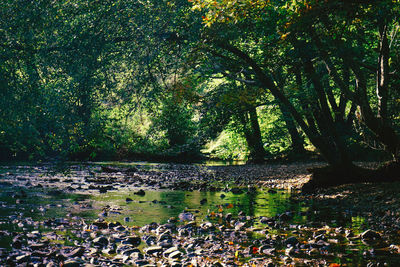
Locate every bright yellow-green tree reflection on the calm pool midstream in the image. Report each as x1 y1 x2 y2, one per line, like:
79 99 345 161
86 191 300 226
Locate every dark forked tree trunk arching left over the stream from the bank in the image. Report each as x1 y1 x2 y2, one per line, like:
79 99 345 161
219 43 400 190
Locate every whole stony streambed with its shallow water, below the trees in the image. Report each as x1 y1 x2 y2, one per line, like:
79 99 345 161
0 162 400 266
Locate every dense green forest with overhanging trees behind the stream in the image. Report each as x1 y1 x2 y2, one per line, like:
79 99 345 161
0 0 400 184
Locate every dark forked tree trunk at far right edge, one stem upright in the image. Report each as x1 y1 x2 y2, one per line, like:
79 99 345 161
311 17 400 161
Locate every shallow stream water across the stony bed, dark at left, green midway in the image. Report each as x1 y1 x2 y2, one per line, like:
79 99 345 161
0 163 400 266
